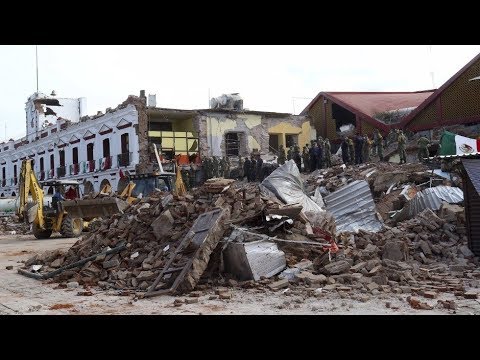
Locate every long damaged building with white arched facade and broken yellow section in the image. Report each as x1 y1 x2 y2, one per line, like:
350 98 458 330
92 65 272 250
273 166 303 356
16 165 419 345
0 90 316 197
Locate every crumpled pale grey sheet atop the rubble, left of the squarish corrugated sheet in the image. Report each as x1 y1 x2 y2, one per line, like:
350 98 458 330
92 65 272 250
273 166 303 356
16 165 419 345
261 160 324 212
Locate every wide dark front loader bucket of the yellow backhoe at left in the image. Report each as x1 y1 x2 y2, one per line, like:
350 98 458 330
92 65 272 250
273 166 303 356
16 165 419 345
59 197 128 219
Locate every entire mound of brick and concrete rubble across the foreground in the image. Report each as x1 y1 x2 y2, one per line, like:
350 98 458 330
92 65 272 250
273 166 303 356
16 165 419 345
16 163 480 309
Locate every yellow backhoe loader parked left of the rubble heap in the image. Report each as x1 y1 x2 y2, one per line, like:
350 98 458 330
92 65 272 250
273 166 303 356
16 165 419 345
16 159 128 239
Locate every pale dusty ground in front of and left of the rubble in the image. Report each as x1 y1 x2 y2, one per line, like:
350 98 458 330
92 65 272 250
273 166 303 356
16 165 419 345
0 235 480 315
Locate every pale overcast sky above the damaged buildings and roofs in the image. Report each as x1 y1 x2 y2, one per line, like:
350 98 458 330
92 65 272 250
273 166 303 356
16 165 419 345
0 45 480 141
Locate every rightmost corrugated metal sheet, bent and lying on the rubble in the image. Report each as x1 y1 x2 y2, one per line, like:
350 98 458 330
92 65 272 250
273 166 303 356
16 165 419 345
394 185 463 221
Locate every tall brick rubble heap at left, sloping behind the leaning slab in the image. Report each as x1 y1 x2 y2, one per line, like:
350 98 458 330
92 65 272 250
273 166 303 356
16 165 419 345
25 179 320 290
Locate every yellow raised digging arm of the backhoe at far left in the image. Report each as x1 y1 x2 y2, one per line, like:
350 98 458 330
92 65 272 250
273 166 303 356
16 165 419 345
17 159 45 229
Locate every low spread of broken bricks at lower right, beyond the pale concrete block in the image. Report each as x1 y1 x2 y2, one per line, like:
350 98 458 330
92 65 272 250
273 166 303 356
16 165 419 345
280 203 480 297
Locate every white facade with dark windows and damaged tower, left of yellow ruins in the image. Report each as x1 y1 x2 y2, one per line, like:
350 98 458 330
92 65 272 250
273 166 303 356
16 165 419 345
0 93 139 197
